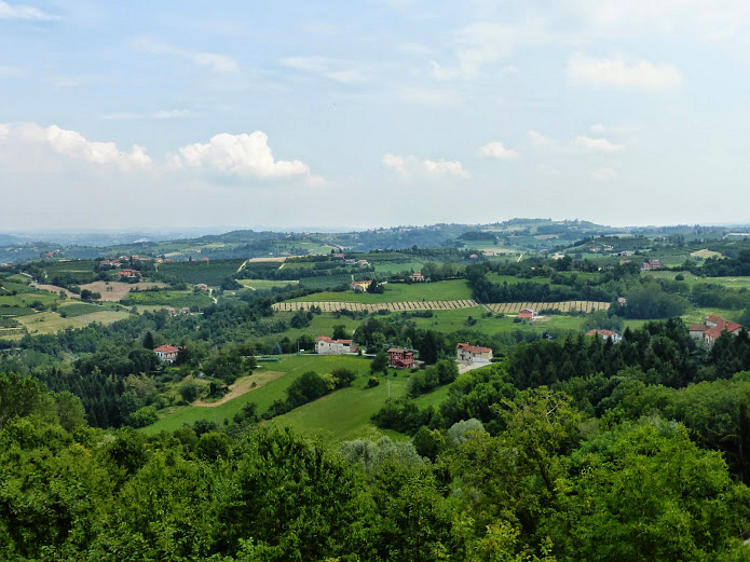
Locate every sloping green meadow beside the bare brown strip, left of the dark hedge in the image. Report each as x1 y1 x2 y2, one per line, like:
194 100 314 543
142 355 388 433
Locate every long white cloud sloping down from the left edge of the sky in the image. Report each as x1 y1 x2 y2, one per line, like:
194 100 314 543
5 123 151 171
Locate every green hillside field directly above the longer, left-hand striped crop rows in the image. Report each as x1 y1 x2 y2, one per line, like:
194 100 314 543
292 279 471 304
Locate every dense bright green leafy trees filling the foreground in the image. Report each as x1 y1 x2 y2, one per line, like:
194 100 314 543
0 366 750 562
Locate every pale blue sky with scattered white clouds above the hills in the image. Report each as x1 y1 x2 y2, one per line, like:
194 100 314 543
0 0 750 231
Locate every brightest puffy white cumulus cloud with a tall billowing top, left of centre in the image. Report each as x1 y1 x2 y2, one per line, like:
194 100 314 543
176 131 312 177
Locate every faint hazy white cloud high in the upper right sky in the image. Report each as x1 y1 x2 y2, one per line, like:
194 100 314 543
567 54 682 90
